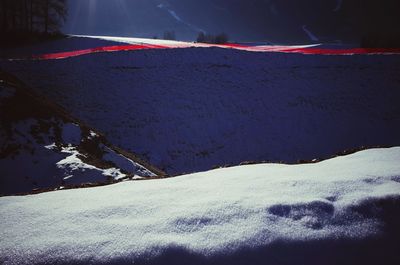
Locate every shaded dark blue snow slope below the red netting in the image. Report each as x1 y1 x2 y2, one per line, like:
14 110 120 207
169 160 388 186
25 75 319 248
0 40 400 174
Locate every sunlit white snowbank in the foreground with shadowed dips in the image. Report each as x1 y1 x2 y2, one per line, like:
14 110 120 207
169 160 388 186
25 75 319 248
0 147 400 265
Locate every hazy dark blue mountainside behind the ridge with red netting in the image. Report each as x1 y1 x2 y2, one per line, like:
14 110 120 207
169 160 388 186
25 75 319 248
64 0 400 43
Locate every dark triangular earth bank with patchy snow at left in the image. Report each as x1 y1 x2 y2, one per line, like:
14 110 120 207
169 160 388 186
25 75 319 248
0 72 161 195
